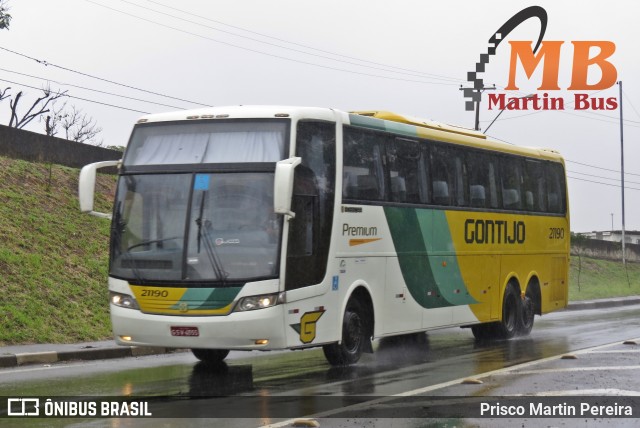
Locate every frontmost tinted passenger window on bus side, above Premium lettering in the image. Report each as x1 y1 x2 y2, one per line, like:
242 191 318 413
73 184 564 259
342 127 386 201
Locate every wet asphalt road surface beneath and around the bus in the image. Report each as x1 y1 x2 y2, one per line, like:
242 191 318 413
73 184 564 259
0 305 640 427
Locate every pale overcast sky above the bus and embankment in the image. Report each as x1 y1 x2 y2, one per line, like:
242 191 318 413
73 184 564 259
0 0 640 232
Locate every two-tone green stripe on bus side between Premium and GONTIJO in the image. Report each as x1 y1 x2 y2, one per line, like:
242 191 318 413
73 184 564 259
384 207 477 308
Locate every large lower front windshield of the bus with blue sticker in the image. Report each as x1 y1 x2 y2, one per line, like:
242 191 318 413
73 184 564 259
110 172 282 285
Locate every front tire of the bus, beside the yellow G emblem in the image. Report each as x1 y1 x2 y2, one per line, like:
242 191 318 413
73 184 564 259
322 299 369 366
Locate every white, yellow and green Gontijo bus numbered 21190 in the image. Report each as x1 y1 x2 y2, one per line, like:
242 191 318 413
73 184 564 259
79 106 570 365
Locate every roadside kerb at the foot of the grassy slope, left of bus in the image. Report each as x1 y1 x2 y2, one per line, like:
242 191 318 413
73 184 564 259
0 345 183 368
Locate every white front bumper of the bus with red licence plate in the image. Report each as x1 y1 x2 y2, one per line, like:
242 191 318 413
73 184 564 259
111 305 286 351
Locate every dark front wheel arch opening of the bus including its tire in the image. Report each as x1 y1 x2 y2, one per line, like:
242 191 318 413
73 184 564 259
322 286 375 366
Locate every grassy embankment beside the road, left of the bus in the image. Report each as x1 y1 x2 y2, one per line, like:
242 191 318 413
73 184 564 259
0 157 115 346
